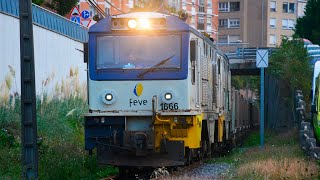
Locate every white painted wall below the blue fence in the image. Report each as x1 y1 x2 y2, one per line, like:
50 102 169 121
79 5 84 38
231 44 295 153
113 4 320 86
0 13 86 94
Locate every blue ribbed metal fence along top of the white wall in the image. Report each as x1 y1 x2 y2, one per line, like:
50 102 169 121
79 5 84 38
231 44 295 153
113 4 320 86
0 0 88 42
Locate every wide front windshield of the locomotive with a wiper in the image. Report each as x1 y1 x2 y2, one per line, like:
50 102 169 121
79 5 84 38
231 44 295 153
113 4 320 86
97 35 181 69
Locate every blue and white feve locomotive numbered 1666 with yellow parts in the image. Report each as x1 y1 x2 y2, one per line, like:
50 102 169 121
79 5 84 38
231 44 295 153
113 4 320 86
85 12 245 167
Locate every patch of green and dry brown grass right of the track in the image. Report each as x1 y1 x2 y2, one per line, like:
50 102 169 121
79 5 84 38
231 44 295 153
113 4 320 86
210 131 320 179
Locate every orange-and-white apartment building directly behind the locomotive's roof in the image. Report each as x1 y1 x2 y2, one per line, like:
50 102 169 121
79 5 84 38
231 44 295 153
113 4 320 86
78 0 218 39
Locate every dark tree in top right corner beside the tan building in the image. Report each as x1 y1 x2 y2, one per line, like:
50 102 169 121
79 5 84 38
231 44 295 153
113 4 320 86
295 0 320 44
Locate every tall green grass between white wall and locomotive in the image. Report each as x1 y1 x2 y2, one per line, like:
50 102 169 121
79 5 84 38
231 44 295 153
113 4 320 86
0 97 118 179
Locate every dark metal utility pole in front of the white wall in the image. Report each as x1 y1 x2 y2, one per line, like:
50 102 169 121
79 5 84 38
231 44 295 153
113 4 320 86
19 0 38 179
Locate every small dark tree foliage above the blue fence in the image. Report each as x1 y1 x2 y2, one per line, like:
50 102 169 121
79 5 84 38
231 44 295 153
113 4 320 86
47 0 79 16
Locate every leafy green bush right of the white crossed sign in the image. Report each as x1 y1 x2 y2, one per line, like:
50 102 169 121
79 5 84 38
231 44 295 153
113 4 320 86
268 37 312 94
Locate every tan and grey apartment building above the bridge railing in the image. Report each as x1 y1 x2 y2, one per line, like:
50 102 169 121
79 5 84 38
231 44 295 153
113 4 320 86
218 0 303 51
